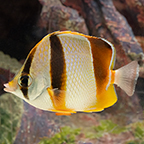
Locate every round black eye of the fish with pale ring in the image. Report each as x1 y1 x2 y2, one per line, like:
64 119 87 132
18 74 32 87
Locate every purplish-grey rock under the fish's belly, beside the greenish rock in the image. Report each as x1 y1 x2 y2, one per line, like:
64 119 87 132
14 102 59 144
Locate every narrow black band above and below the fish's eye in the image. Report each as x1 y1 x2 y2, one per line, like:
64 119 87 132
20 47 36 99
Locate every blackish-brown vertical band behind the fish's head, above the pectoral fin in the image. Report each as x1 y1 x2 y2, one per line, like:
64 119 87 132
50 34 66 90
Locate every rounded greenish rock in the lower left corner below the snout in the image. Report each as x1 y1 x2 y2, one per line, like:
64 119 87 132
0 93 23 144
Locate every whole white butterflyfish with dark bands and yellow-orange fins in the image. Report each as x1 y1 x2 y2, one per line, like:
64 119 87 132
4 31 139 115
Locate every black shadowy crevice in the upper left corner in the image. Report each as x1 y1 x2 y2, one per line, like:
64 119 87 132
0 0 42 60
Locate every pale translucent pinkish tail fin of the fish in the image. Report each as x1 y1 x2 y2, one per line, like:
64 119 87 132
114 61 139 96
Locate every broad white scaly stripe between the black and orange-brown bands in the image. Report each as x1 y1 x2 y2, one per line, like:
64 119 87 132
58 34 96 111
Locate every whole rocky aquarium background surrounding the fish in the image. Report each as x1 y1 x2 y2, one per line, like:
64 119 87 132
0 0 144 144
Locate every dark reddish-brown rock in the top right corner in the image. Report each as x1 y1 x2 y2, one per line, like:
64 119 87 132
113 0 144 36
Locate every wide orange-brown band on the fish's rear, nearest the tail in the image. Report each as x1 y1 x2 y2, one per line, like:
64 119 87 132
88 38 112 93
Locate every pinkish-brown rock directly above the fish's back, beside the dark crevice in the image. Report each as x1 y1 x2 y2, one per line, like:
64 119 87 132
39 0 88 34
